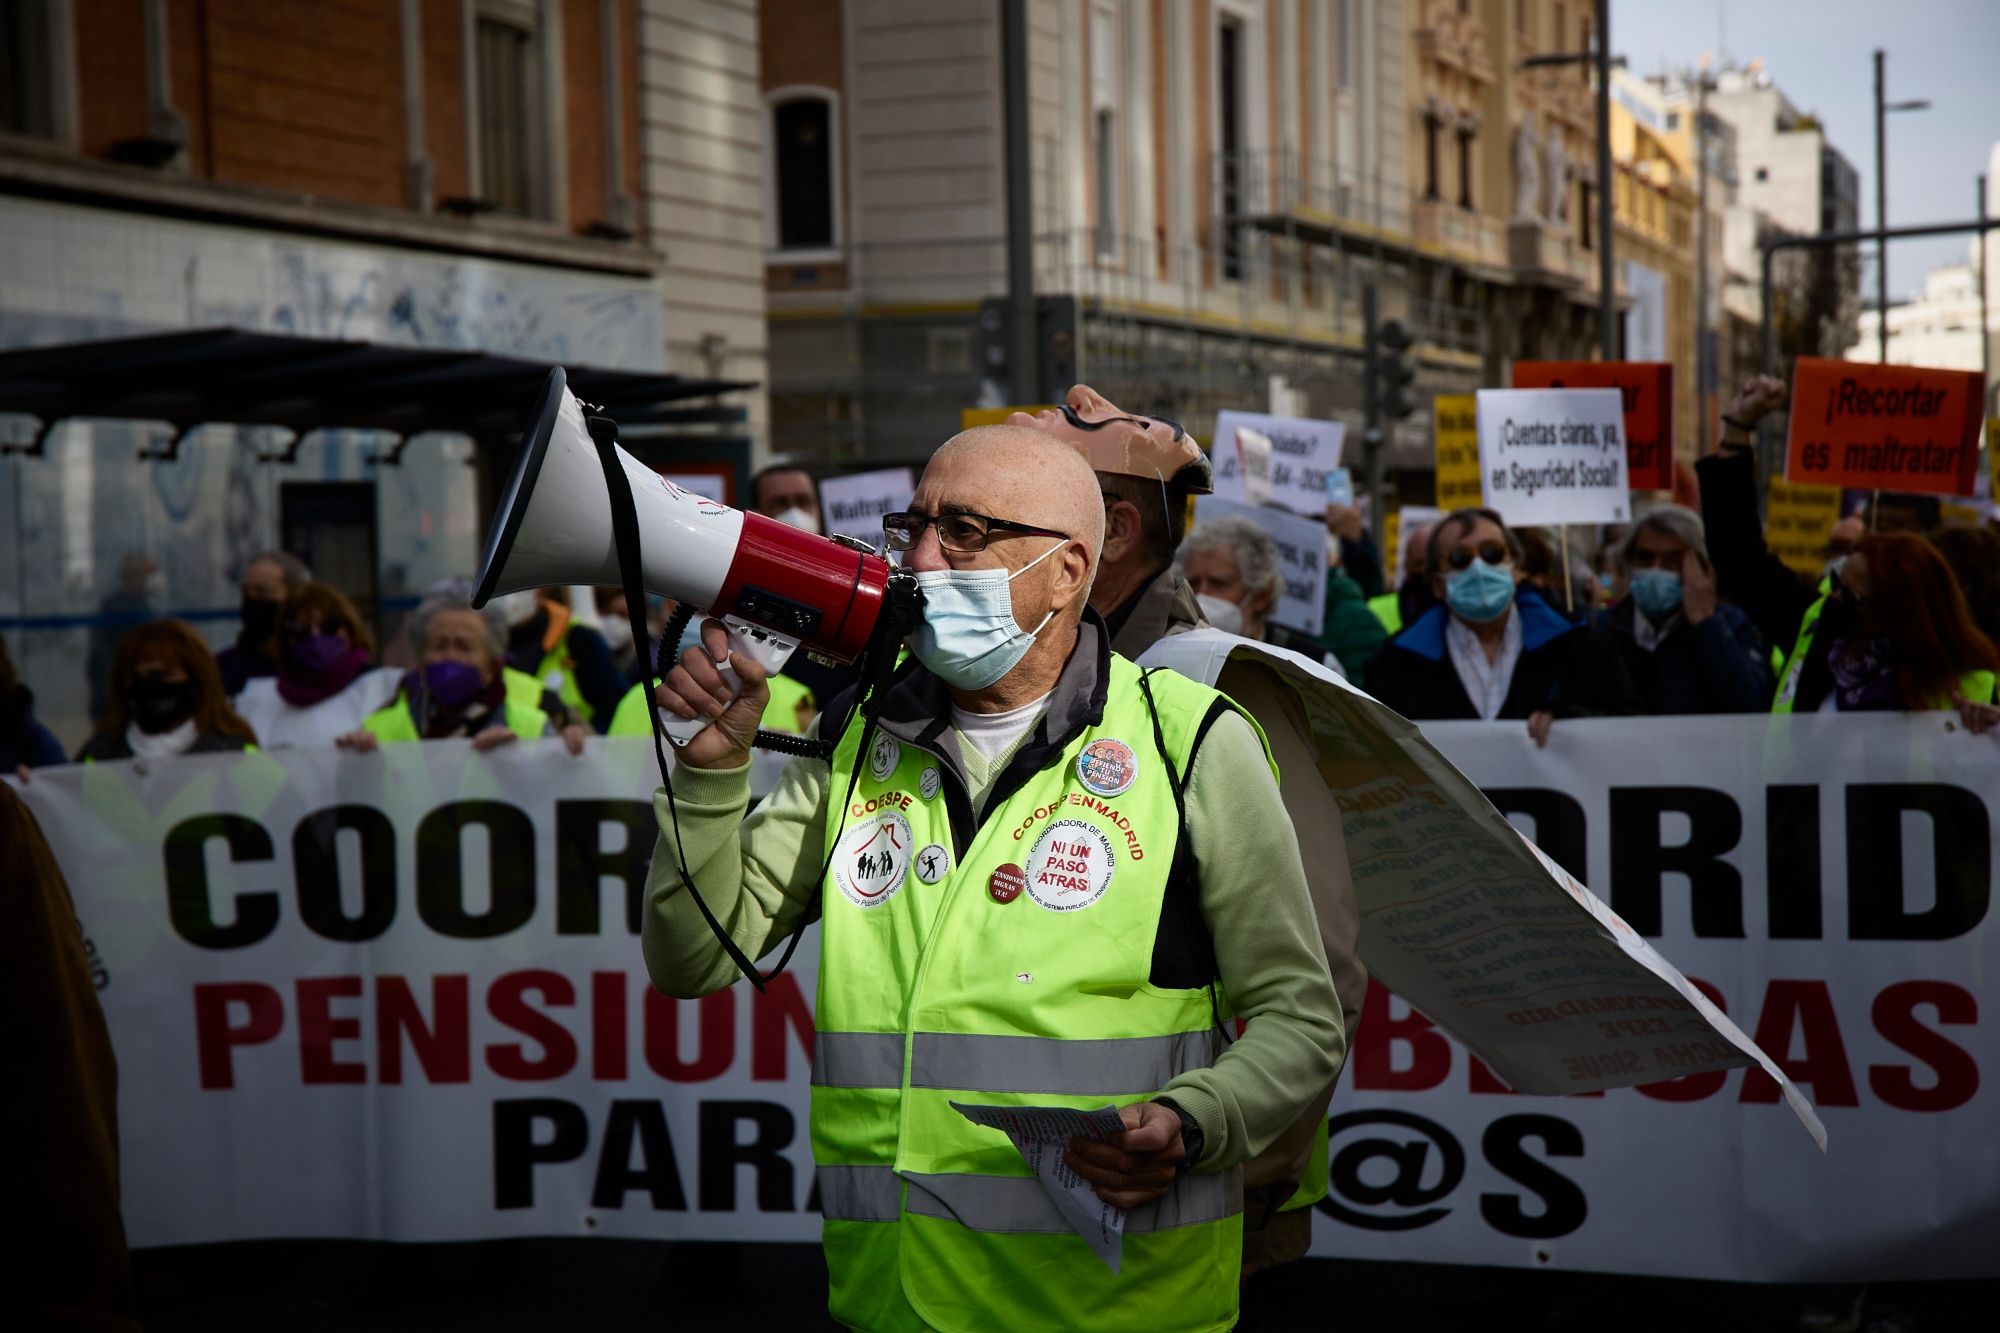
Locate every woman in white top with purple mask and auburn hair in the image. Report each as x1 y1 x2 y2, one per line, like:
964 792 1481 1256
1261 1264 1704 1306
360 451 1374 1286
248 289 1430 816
236 582 402 749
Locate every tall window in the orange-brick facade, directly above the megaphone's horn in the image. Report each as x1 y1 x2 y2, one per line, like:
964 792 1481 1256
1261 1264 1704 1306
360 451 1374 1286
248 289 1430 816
474 0 550 218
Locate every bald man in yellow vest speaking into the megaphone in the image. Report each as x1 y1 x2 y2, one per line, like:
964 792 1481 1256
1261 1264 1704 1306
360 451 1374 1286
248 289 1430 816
642 424 1346 1333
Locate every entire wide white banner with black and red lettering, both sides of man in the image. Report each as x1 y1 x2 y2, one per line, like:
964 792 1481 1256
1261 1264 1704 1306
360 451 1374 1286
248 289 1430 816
20 704 2000 1283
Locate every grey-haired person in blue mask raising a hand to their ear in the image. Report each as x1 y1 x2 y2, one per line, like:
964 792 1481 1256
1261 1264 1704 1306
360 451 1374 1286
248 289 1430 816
1598 504 1772 715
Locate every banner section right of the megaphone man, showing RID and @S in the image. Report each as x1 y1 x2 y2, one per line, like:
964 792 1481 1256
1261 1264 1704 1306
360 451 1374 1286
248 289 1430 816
1288 713 2000 1283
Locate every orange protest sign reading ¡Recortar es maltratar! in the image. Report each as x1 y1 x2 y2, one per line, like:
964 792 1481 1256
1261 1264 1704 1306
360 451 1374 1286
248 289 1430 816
1784 356 1984 494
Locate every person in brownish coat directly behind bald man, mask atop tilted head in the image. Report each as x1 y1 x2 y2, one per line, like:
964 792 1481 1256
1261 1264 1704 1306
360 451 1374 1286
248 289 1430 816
1022 384 1394 1280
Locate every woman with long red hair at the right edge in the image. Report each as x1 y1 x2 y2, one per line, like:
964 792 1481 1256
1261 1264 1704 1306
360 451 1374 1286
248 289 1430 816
1816 532 2000 733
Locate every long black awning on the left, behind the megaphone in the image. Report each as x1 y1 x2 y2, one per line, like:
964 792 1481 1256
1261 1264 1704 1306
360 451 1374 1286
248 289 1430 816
0 328 752 456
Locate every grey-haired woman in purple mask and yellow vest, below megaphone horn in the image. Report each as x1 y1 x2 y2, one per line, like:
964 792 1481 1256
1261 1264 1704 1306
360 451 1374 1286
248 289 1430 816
338 578 584 755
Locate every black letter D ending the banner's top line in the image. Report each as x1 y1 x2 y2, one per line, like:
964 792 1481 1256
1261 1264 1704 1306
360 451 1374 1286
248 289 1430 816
1848 783 1994 939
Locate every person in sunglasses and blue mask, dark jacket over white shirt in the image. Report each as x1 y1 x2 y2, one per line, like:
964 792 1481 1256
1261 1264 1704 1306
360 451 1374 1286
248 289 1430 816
1368 508 1642 747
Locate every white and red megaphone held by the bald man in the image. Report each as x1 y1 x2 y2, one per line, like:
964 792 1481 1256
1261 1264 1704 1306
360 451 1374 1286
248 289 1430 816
472 366 890 743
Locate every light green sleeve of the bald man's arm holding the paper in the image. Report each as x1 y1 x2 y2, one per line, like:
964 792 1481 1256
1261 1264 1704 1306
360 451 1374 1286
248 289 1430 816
1162 713 1346 1171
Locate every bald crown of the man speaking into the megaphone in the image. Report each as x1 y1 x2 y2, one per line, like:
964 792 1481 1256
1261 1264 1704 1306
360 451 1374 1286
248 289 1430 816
918 424 1104 572
